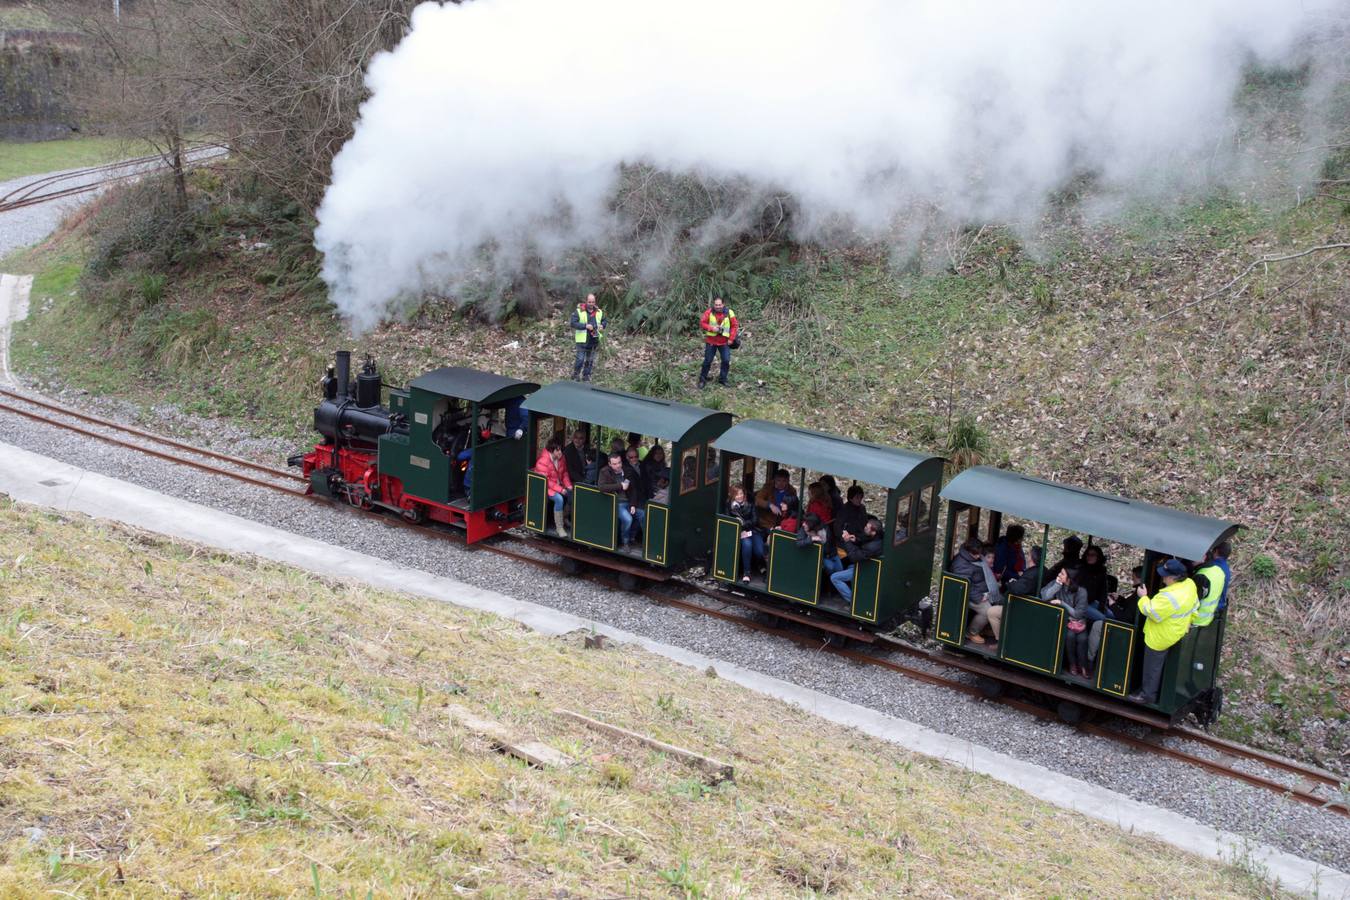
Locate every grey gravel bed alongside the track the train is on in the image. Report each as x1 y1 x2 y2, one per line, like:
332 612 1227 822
0 393 1350 868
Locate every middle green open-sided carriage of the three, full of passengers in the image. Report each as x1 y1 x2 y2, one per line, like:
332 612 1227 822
710 420 942 626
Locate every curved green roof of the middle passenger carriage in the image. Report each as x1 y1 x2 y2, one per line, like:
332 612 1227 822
714 418 941 490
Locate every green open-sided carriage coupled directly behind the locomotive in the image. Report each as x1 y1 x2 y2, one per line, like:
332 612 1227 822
524 382 732 573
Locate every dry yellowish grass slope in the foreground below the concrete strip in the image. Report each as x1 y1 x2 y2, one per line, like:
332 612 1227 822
0 498 1285 897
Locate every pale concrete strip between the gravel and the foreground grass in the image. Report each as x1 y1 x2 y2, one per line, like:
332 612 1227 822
0 444 1350 897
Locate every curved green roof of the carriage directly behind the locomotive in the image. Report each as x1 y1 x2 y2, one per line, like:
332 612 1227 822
524 382 732 443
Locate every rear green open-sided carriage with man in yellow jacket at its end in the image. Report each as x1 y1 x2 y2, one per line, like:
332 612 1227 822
936 466 1239 722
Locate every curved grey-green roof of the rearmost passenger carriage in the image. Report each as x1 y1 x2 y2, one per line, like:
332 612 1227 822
942 466 1241 560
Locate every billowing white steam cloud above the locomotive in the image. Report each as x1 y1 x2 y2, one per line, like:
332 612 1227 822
316 0 1350 329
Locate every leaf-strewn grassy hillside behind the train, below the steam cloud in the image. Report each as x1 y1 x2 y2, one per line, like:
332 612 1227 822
9 165 1350 770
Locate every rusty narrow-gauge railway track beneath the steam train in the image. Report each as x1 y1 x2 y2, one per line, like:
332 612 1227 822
0 387 1350 818
